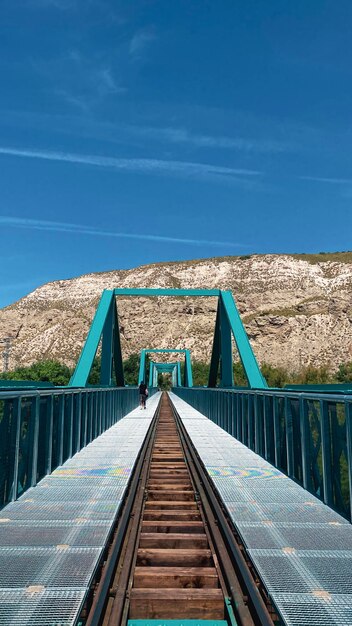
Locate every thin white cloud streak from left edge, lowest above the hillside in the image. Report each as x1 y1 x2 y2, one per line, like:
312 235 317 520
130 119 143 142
0 215 248 248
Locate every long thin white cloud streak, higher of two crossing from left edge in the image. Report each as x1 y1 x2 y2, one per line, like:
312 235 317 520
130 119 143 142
0 147 262 182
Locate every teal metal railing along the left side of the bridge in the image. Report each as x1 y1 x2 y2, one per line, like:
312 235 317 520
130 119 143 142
0 387 145 508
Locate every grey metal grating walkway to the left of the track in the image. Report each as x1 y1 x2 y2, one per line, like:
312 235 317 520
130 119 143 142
0 394 160 626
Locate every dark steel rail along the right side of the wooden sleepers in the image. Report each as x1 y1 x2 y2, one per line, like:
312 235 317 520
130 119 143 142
169 399 273 626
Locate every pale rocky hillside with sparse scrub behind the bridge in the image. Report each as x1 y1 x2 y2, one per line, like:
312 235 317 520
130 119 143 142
0 253 352 370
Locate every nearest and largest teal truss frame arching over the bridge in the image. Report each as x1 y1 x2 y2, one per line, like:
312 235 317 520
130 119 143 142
68 289 267 389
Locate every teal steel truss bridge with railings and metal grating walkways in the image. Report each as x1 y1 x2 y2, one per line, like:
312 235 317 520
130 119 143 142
0 289 352 626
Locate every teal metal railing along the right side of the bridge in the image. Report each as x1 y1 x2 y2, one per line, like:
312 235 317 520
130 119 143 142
173 387 352 520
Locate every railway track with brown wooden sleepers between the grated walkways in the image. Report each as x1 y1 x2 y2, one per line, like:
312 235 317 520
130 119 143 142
82 393 274 626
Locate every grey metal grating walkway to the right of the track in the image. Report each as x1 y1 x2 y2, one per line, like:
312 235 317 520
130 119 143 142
170 393 352 626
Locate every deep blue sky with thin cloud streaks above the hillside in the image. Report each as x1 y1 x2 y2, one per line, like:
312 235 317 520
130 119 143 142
0 0 352 306
